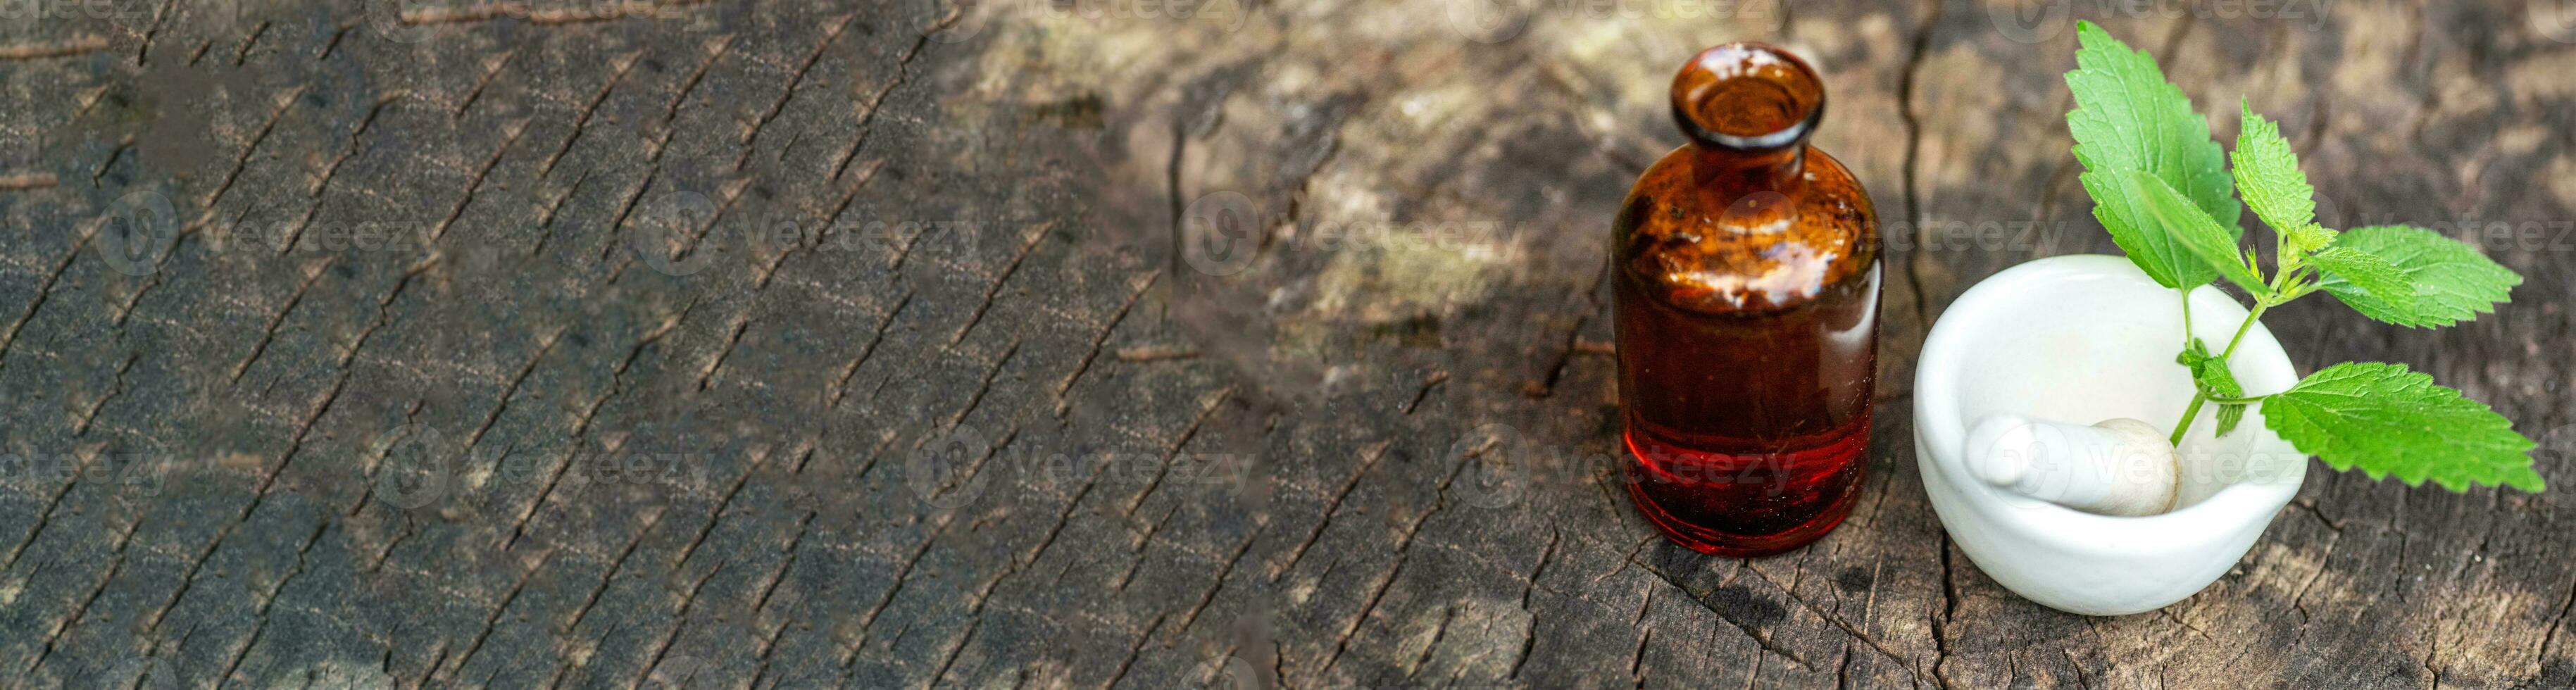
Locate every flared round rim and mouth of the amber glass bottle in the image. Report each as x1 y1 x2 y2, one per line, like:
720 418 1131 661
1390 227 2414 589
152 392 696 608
1672 44 1824 152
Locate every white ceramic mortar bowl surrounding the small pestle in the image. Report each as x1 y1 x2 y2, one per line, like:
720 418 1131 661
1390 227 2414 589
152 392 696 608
1914 255 2308 615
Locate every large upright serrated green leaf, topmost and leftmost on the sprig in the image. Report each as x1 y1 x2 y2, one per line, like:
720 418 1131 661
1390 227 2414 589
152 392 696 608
2066 20 2244 289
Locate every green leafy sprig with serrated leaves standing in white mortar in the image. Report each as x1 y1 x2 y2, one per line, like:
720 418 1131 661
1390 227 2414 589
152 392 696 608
2066 20 2545 491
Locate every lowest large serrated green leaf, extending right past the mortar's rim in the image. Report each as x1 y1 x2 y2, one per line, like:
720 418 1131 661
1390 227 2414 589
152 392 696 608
2262 363 2545 491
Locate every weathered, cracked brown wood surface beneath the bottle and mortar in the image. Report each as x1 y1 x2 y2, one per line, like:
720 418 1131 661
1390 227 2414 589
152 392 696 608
0 0 2576 687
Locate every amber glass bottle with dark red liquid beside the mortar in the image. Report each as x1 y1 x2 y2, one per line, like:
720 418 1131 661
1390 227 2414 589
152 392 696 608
1610 44 1878 556
